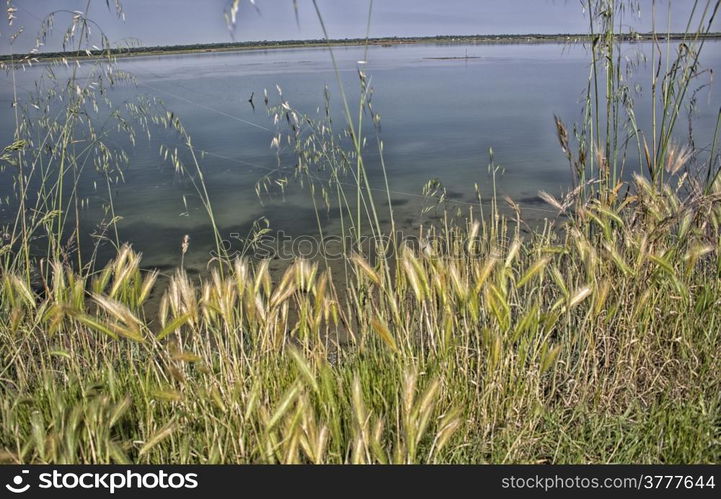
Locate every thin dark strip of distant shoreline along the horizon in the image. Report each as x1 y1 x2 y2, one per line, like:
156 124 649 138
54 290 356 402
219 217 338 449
0 33 721 62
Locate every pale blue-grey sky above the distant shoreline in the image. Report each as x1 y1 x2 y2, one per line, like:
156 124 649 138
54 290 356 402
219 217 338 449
0 0 721 54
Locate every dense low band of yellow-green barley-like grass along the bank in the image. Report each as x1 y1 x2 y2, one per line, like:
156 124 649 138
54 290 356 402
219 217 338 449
0 178 721 463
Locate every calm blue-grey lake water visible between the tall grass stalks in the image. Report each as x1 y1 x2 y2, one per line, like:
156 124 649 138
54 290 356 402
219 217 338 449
0 43 721 267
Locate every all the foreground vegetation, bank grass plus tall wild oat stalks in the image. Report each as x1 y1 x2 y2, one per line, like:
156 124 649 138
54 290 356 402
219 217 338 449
0 0 721 463
